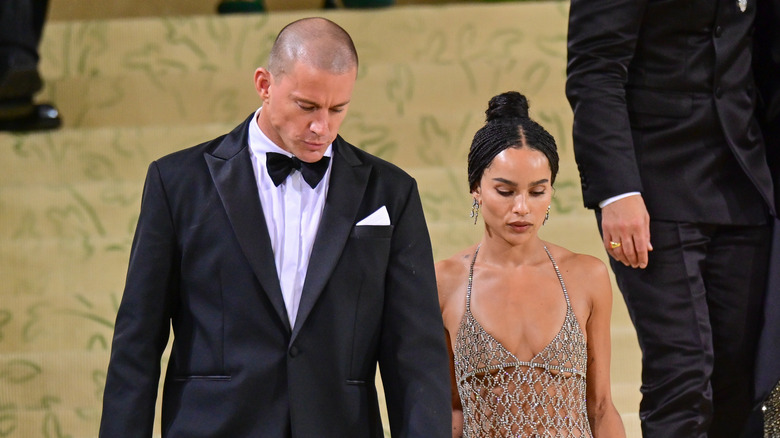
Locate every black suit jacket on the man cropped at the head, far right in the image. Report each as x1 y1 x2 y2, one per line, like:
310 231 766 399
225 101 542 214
566 0 774 225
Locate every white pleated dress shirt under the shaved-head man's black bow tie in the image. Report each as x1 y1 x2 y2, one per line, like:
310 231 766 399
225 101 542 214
249 108 333 327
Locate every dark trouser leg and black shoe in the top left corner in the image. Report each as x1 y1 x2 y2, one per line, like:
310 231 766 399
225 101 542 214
0 0 61 132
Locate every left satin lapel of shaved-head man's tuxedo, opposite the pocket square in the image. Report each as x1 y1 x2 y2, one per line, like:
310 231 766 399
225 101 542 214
205 116 290 331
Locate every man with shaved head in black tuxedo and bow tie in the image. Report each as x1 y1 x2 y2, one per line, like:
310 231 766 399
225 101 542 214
100 18 451 438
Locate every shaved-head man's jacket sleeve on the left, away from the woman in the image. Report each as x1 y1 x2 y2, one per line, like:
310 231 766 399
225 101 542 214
99 163 177 438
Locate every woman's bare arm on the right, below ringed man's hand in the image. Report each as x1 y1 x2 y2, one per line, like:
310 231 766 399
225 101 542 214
580 257 626 438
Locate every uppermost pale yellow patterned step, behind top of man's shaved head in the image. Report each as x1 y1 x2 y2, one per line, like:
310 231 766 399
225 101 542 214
41 2 568 76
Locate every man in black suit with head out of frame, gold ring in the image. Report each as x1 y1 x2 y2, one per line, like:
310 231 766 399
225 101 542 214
566 0 775 438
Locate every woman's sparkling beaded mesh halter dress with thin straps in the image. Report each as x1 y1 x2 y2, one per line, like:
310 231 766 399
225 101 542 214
453 247 592 438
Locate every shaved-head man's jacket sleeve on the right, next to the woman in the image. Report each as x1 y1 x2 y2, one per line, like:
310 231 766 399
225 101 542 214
379 179 452 438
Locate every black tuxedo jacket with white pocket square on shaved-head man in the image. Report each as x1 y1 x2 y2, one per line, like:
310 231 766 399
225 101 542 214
100 117 451 438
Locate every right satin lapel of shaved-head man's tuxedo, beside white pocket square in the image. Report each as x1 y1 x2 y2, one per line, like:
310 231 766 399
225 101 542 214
290 137 371 342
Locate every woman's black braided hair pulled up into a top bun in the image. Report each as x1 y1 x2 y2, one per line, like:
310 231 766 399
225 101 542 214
468 91 558 192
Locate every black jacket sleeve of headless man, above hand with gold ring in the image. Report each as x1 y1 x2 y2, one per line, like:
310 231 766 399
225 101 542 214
566 0 647 208
